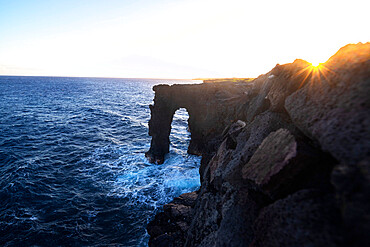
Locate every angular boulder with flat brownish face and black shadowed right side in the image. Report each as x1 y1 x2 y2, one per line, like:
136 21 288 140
242 129 336 200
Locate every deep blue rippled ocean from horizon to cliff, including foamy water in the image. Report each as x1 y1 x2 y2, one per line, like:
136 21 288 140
0 76 200 246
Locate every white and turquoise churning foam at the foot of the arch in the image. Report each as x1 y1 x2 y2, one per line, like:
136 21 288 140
109 152 200 208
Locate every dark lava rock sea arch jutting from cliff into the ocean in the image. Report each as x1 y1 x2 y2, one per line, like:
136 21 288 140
145 83 249 164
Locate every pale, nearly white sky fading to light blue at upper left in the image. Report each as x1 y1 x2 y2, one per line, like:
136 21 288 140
0 0 370 79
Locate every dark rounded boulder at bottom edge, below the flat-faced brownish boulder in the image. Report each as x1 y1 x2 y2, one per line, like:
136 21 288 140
250 190 342 247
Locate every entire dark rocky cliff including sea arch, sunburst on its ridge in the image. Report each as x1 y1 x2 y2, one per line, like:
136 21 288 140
146 43 370 247
